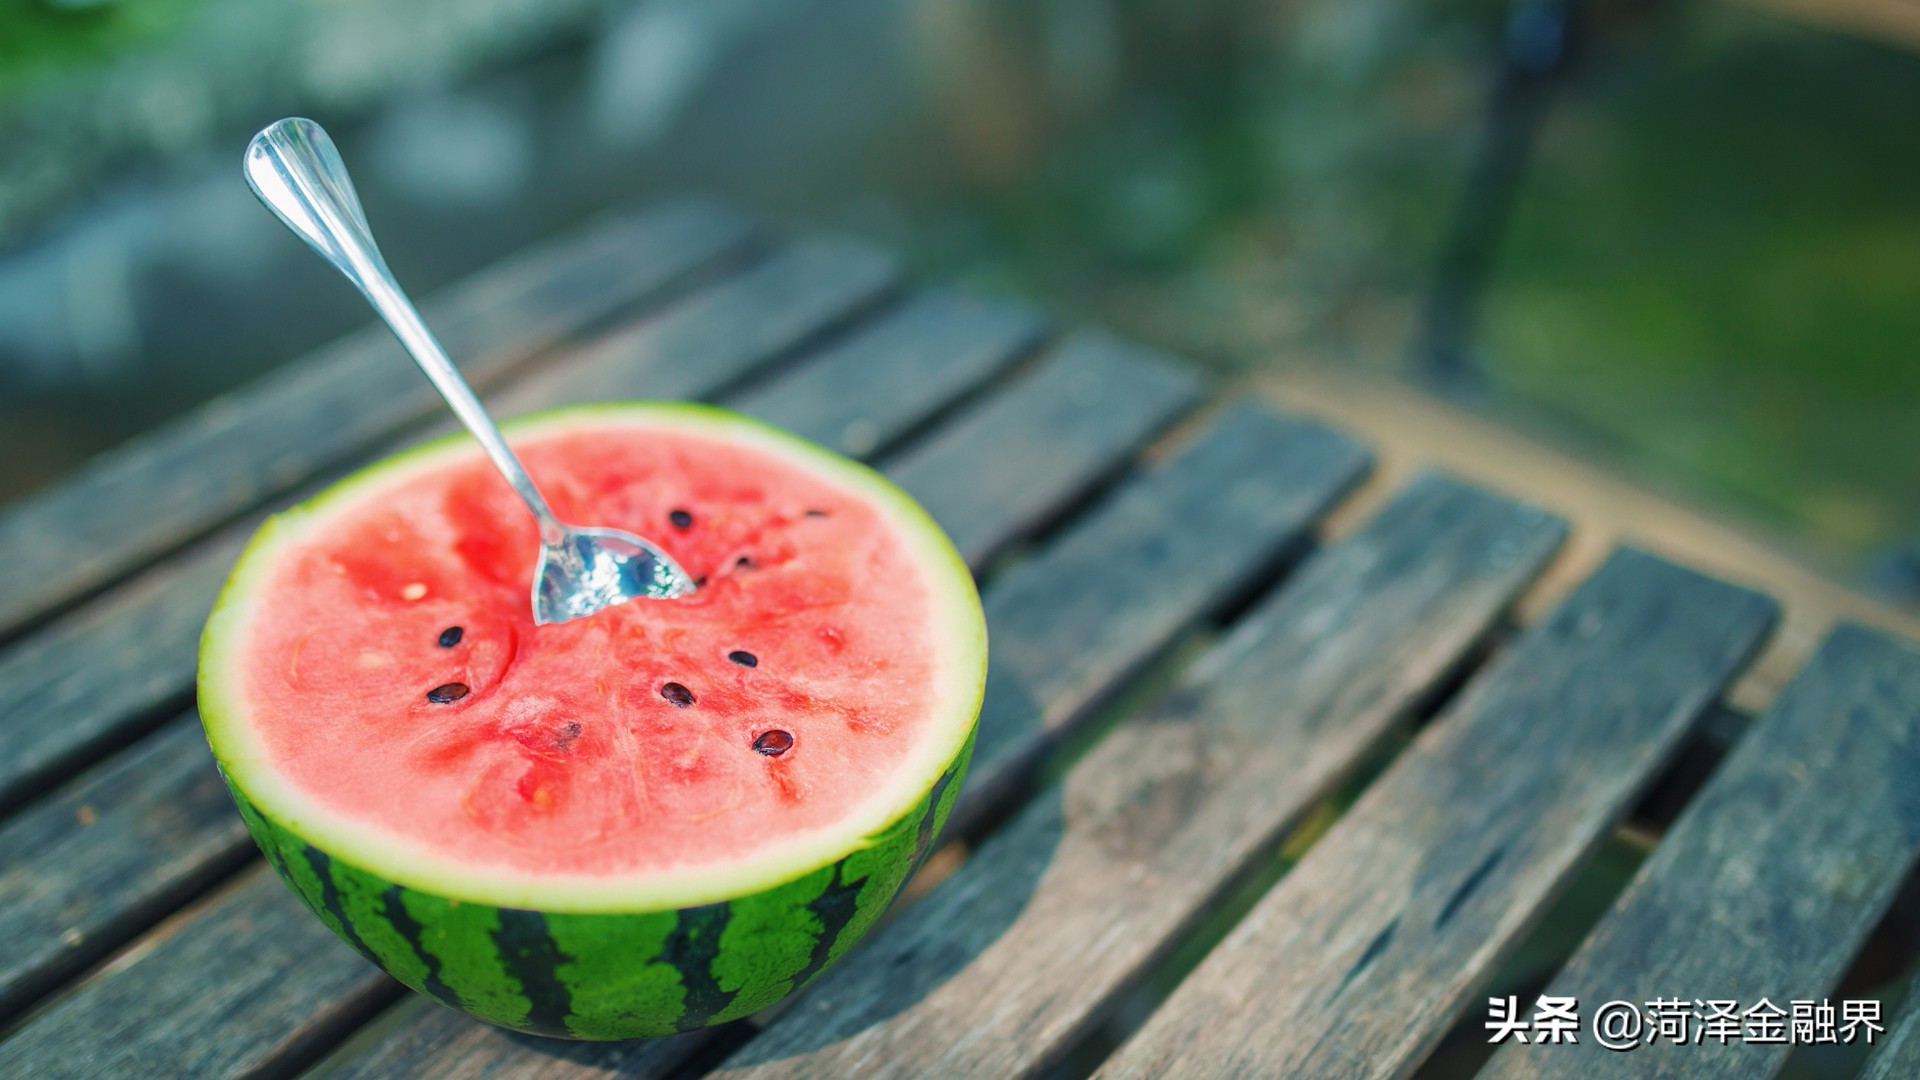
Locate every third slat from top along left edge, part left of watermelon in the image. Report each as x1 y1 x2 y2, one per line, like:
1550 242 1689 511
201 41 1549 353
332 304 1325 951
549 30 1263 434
0 717 253 1024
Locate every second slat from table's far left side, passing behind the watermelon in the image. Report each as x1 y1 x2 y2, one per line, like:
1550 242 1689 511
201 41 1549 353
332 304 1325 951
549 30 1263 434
0 238 898 813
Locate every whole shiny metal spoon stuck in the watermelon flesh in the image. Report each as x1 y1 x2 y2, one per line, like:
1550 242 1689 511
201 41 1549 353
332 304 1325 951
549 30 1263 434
246 117 693 623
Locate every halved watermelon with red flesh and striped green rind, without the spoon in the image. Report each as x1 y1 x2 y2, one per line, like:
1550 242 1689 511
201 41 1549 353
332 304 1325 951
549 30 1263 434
200 404 987 1038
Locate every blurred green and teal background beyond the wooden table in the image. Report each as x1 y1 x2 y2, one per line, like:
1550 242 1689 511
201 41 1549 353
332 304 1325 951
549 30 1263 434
0 0 1920 1076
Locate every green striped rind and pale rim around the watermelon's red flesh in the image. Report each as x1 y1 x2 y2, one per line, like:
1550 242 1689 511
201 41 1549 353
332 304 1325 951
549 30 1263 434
198 402 987 1038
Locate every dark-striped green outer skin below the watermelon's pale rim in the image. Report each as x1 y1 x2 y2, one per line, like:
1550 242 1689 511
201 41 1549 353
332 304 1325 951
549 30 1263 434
227 734 973 1040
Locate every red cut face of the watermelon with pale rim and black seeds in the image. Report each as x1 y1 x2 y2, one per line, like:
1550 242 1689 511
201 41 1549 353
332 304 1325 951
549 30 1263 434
204 407 983 911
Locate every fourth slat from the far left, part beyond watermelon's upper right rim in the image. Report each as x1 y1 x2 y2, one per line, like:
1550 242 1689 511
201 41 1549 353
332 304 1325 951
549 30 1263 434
895 332 1200 563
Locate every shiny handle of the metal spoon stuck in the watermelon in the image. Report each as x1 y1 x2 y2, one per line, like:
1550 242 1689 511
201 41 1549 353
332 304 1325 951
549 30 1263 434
246 117 564 544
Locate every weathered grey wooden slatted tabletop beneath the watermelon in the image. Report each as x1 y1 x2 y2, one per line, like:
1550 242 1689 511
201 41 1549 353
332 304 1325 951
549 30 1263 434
0 202 1920 1078
